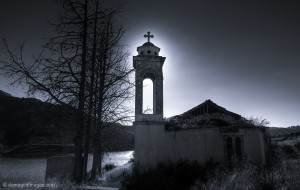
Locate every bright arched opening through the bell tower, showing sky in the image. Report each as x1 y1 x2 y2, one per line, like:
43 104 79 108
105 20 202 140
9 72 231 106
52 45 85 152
143 78 153 114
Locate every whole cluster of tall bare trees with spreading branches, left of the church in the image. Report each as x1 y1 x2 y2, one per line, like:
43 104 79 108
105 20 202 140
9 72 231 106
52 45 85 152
0 0 133 183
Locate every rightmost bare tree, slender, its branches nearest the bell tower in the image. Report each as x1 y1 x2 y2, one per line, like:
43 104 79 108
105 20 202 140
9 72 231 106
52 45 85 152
86 15 133 180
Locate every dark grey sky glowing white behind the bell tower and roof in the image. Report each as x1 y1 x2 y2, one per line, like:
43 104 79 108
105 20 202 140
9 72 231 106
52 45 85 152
0 0 300 127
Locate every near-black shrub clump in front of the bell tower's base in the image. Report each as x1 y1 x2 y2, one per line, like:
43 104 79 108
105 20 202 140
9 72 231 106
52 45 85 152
122 160 206 190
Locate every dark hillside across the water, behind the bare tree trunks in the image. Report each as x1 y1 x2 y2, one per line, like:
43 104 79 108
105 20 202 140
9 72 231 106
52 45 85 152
0 91 134 154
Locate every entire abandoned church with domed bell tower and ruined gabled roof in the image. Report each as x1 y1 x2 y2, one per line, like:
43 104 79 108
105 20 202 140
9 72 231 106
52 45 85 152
133 32 269 167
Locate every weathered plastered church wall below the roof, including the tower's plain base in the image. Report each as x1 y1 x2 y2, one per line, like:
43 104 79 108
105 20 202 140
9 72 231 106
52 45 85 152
135 122 266 166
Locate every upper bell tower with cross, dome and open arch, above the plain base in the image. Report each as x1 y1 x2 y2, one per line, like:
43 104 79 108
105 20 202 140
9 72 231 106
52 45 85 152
133 32 166 121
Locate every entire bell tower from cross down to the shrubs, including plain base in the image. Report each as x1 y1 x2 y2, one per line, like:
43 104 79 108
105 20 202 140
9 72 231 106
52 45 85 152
133 32 166 166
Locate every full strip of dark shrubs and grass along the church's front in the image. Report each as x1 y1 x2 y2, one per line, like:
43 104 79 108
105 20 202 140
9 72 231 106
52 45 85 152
122 157 300 190
